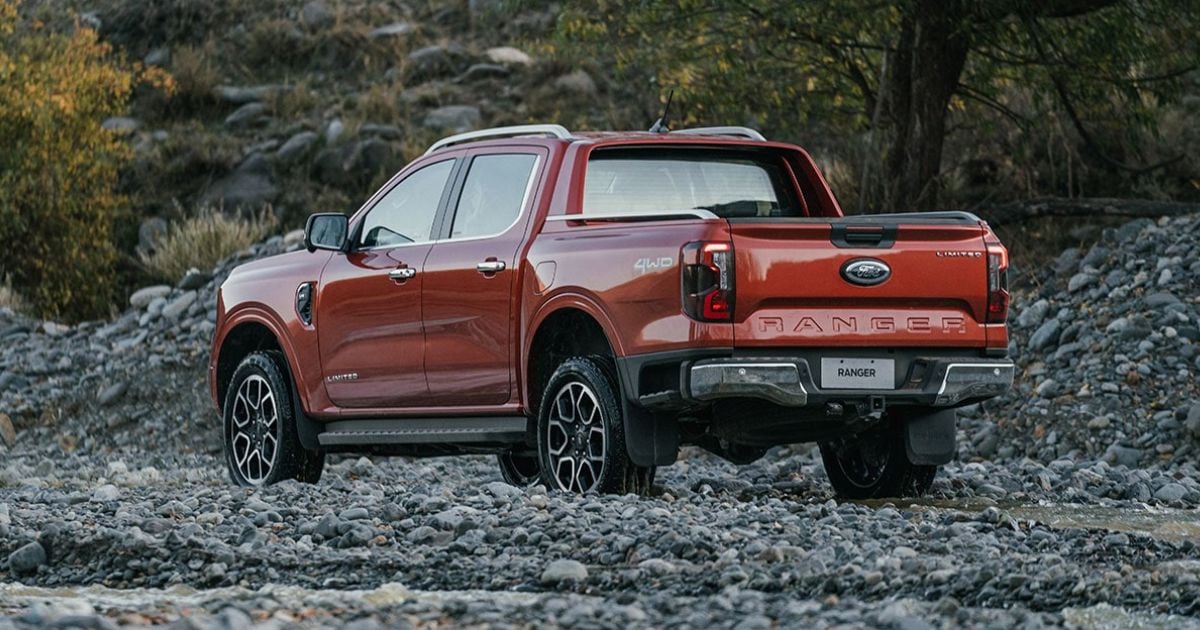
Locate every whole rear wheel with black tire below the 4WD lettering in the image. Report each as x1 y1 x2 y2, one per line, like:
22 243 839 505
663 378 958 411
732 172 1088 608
538 356 654 494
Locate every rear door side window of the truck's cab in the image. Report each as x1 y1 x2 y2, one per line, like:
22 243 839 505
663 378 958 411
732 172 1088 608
450 154 538 239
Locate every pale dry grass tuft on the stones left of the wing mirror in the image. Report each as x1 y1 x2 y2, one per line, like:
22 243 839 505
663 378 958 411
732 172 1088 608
140 209 275 282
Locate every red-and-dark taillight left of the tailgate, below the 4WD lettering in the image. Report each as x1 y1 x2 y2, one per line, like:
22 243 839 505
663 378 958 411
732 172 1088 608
680 241 733 322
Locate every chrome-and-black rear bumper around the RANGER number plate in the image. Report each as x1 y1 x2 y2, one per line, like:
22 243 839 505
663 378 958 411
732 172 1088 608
680 358 1015 409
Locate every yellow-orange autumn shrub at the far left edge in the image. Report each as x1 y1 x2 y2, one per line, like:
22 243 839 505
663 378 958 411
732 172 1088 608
0 0 169 320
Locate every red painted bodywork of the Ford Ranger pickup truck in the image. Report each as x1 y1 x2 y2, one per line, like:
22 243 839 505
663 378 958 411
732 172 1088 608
210 133 1008 420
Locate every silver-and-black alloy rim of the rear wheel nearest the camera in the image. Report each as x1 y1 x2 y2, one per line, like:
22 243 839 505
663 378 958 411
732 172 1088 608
546 380 608 493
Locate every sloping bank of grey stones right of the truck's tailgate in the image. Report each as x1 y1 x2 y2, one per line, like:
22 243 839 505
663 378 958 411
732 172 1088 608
960 216 1200 465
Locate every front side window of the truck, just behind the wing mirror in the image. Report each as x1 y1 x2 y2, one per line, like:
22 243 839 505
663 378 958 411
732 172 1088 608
359 160 454 248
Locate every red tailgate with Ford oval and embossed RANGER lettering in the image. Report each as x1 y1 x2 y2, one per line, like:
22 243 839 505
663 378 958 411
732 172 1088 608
730 215 988 348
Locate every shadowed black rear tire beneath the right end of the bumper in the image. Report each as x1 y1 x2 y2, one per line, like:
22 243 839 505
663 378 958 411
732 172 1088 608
821 418 938 499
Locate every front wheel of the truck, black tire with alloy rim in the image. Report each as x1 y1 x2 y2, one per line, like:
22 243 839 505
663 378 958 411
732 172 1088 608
222 352 325 486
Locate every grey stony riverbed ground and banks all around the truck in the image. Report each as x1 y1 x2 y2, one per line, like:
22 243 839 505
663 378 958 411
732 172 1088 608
0 218 1200 628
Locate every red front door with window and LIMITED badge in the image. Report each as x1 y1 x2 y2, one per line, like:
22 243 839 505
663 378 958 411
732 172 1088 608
313 158 455 408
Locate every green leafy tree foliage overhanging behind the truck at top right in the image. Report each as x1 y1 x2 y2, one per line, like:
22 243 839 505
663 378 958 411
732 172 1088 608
542 0 1200 208
